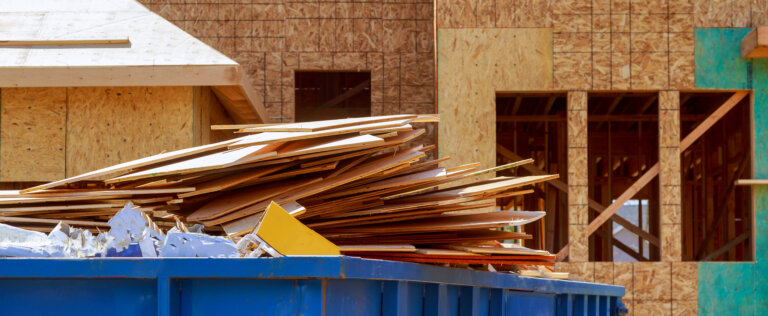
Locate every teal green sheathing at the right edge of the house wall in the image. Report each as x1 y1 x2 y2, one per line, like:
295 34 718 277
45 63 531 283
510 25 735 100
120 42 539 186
695 28 768 315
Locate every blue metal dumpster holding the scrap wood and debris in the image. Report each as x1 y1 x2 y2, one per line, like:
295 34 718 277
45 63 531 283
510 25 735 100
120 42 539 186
0 257 624 316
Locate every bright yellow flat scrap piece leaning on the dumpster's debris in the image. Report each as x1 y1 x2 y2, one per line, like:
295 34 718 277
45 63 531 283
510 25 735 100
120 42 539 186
256 202 341 256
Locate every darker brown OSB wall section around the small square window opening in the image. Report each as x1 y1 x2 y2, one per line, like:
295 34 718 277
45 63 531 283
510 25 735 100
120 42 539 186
141 0 435 128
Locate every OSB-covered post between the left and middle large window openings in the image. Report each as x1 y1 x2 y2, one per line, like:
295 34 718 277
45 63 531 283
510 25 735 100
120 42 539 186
567 91 589 262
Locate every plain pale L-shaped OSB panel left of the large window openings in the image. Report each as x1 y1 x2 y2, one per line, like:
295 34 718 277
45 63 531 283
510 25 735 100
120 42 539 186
437 29 552 181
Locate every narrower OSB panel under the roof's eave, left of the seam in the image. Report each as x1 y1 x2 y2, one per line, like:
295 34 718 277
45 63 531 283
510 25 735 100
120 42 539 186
0 88 67 182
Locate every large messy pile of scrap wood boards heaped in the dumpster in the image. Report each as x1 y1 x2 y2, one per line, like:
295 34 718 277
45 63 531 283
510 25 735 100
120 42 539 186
0 115 557 265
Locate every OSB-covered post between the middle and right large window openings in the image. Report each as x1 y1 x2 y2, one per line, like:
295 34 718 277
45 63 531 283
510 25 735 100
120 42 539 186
659 91 682 261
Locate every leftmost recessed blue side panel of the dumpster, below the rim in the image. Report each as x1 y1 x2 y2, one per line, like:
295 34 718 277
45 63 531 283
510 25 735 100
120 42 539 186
0 278 157 316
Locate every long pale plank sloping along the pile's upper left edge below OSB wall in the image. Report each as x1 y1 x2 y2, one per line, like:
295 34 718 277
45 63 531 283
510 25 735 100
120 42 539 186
21 139 237 193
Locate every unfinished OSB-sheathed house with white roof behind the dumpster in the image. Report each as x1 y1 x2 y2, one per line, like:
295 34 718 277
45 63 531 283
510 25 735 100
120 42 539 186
0 0 768 315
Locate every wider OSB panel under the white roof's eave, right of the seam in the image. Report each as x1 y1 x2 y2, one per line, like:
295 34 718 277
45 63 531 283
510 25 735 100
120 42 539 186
66 87 195 177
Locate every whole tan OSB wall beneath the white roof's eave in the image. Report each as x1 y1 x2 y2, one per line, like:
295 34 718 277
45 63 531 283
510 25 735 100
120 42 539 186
0 87 200 182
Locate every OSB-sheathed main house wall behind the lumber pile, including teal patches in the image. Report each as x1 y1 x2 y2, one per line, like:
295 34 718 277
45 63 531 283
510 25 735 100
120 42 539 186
132 0 768 315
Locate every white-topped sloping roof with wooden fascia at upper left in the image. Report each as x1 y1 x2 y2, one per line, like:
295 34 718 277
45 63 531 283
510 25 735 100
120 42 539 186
0 0 267 123
